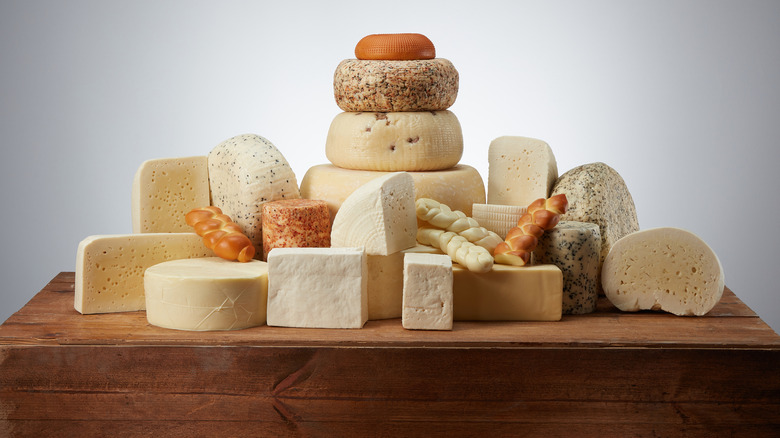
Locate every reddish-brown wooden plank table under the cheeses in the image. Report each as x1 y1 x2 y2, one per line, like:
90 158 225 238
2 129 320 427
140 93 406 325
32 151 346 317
0 272 780 437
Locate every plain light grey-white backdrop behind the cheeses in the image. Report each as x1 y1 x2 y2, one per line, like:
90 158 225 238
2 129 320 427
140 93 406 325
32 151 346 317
0 0 780 331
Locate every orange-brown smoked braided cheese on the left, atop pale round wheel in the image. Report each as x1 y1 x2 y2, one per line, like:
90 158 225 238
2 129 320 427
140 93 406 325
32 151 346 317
184 206 255 263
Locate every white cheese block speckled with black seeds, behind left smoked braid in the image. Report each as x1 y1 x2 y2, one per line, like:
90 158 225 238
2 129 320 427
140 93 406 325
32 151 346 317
208 134 300 258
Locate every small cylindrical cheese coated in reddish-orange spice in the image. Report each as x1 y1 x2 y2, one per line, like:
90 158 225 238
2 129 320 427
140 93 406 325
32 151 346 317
263 199 330 260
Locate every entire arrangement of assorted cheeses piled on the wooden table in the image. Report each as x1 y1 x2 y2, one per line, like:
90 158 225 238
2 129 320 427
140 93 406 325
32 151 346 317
74 30 724 336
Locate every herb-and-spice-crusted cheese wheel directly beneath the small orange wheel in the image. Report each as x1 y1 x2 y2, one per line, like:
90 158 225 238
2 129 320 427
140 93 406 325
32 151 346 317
333 58 458 112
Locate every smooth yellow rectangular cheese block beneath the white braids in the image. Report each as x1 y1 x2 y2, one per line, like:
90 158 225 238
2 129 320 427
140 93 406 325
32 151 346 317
452 264 563 321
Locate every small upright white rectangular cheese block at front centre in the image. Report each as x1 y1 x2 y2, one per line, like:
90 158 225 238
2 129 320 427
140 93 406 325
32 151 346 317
401 253 452 330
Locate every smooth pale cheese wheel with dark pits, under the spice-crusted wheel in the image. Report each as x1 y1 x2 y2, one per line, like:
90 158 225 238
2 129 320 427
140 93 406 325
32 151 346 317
325 111 463 172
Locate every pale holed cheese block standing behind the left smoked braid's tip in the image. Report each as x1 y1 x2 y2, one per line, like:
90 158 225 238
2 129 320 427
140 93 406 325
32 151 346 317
131 157 211 233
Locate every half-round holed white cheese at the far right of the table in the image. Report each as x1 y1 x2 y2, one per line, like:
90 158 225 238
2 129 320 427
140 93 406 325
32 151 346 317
601 227 725 315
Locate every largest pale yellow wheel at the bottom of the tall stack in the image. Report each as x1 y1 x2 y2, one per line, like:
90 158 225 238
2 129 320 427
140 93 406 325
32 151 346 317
301 164 485 220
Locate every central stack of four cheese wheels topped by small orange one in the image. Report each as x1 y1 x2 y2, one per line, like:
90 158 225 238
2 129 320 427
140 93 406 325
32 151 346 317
301 34 486 220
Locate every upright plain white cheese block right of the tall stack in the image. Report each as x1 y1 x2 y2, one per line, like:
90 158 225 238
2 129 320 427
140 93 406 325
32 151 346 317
487 136 558 207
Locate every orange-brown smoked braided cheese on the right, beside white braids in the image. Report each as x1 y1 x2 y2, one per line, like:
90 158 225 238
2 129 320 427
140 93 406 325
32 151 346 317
493 193 569 266
